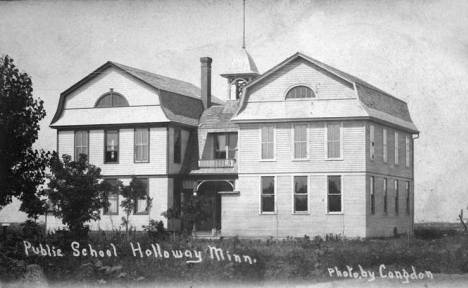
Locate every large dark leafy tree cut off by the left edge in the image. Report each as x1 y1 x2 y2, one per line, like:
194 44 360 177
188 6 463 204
0 56 51 219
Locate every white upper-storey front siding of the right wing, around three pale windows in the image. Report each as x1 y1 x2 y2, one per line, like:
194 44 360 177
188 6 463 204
239 121 365 174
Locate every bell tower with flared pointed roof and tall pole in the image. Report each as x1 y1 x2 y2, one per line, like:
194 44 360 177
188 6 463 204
221 0 260 100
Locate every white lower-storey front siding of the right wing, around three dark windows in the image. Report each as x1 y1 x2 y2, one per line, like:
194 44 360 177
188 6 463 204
221 173 366 237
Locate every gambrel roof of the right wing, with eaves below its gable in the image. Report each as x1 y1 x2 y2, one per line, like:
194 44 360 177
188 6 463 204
233 52 419 133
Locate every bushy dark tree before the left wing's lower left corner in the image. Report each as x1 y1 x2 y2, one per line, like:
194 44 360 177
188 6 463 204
45 153 114 234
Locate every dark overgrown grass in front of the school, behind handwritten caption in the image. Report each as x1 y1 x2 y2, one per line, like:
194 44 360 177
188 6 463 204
0 222 468 284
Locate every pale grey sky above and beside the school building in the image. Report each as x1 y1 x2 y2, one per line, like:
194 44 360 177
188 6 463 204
0 0 468 222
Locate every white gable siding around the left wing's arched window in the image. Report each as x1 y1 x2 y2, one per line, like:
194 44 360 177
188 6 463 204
65 67 159 109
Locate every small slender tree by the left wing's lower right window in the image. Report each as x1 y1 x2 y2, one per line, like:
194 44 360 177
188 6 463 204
120 176 152 232
